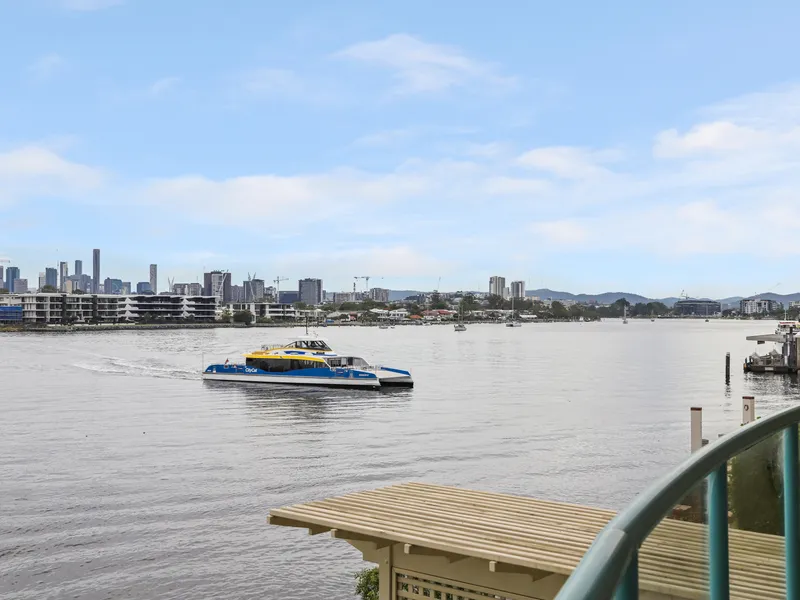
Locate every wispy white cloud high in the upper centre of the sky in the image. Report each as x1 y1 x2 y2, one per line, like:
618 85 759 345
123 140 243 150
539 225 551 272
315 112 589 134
336 33 514 94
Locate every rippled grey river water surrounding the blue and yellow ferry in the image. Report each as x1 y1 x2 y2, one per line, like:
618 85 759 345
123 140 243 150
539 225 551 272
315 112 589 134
0 320 800 600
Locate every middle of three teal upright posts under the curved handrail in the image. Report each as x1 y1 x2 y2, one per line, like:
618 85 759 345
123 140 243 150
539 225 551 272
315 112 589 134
708 461 730 600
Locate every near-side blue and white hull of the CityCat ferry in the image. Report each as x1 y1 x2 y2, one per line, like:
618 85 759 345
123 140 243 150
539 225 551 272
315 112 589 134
203 365 380 389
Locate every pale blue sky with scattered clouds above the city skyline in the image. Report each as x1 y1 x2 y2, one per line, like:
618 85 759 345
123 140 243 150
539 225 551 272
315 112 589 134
0 0 800 297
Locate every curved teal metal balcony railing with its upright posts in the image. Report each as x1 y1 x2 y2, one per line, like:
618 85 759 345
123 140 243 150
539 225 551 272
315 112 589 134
556 406 800 600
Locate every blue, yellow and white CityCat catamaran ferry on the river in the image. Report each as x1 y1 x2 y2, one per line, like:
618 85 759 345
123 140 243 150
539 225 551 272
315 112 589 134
203 336 414 390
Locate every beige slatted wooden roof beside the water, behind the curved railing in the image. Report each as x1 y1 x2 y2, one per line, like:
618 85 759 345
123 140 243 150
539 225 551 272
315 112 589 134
269 483 785 600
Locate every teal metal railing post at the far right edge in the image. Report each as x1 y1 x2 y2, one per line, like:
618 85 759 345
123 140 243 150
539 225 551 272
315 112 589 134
783 423 800 600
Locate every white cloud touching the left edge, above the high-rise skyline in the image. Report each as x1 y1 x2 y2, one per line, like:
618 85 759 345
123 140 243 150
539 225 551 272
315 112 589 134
0 146 106 204
